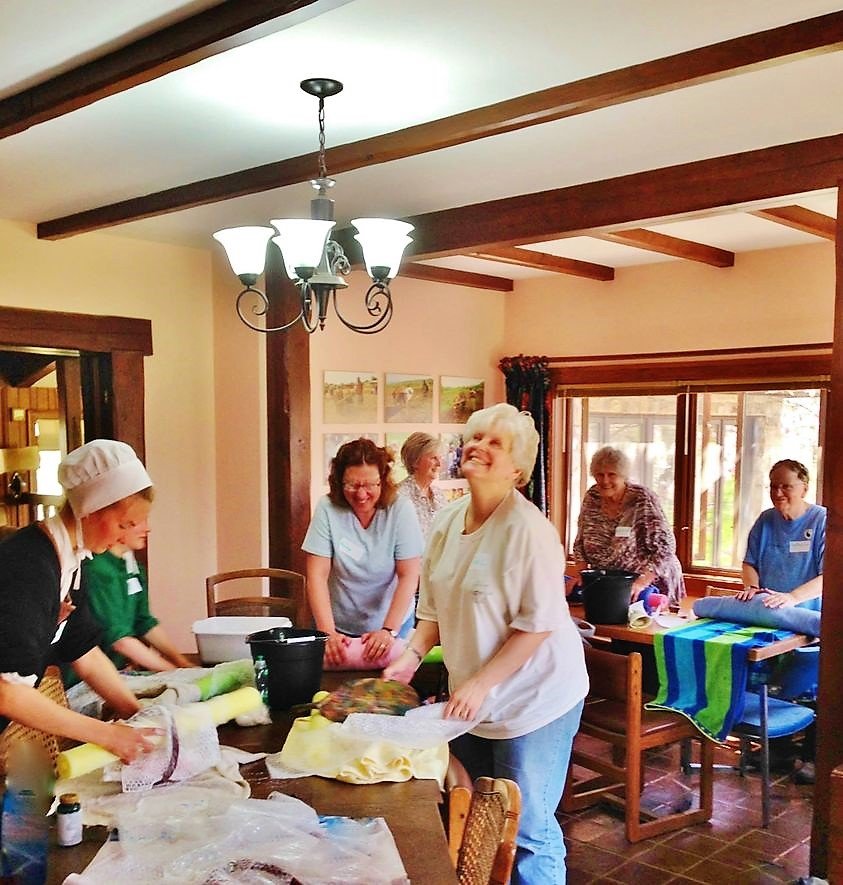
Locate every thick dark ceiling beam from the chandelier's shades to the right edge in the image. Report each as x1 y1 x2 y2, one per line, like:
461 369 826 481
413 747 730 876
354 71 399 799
404 135 843 259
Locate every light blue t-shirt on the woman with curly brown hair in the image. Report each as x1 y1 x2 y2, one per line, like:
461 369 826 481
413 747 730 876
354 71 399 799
301 495 424 636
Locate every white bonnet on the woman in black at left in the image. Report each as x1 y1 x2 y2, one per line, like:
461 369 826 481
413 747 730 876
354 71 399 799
58 439 152 519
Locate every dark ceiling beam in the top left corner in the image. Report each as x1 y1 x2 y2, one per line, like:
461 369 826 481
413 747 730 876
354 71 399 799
0 0 338 138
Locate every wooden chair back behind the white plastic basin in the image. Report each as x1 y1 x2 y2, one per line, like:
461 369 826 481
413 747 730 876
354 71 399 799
205 568 307 626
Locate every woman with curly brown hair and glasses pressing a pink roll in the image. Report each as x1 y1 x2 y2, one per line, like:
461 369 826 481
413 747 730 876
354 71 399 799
302 439 424 667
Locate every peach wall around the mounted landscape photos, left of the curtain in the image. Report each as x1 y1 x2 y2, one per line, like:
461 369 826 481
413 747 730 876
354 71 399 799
310 273 511 506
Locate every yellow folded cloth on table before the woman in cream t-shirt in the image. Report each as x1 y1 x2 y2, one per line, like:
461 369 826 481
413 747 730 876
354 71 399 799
280 711 448 786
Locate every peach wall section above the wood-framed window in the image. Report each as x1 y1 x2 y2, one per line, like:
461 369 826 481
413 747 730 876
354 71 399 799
504 243 834 356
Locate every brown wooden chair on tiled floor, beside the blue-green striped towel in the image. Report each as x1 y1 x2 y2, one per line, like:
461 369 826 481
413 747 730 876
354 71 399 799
562 647 714 842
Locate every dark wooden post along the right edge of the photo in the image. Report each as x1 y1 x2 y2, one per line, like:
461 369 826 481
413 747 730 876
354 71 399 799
811 181 843 878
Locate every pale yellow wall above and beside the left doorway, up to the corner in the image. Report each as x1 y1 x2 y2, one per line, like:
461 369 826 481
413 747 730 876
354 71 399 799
0 221 217 650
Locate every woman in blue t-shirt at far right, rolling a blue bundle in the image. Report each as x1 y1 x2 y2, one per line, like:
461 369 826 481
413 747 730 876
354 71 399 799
738 458 826 611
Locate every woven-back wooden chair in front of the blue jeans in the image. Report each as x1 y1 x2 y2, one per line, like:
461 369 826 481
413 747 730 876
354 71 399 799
448 777 521 885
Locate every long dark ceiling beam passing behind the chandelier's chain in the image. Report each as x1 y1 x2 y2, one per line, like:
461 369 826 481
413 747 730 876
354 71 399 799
38 12 843 239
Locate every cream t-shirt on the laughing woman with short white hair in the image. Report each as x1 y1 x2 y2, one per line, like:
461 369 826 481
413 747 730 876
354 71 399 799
416 491 588 739
